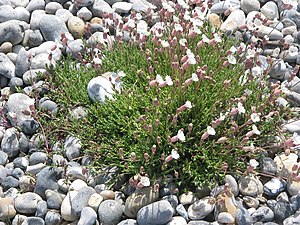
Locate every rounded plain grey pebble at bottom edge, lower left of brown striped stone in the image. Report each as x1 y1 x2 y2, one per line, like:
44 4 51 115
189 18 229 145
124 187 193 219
98 200 123 225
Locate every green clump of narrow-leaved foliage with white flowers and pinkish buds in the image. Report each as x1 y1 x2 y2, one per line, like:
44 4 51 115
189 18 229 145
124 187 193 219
44 1 281 189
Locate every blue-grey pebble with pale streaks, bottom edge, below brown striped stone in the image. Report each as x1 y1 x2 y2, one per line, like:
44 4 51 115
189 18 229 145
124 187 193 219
137 200 174 225
